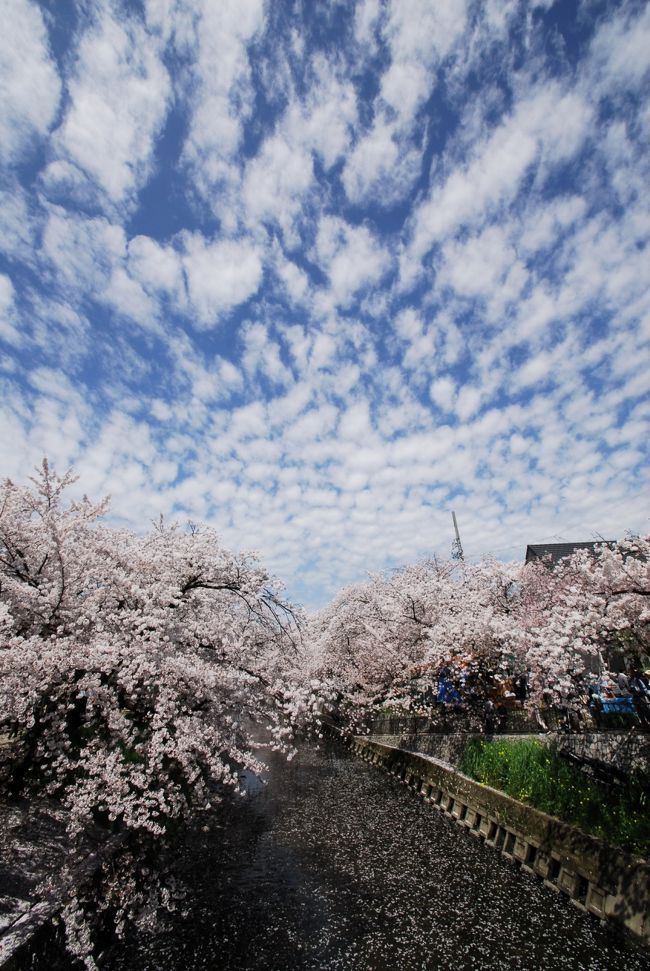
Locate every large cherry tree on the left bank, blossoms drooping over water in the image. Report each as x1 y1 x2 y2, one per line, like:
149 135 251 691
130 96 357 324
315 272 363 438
0 461 318 966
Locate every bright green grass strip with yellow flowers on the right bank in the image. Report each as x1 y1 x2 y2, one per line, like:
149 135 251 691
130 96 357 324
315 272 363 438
459 739 650 857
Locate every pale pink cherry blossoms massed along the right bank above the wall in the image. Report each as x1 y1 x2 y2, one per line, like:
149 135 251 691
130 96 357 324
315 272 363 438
309 538 650 728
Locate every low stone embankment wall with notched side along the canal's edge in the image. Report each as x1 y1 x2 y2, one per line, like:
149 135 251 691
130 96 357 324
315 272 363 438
351 737 650 946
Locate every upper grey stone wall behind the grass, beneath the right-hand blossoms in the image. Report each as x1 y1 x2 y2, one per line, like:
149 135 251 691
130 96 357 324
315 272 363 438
368 719 650 772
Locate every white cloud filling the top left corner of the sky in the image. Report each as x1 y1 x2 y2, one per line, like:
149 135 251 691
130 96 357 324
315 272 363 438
0 0 61 162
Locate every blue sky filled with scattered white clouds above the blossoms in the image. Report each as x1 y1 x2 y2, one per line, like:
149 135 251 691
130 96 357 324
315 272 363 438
0 0 650 606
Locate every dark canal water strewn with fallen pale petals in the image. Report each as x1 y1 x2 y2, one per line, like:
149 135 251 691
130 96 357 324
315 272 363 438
109 744 650 971
